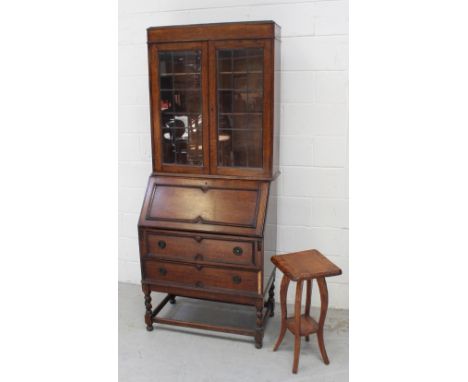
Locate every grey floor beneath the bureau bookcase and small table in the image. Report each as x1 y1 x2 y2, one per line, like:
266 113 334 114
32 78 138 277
119 283 348 382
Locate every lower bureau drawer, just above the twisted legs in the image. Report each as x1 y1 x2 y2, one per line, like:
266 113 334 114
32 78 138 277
144 260 258 292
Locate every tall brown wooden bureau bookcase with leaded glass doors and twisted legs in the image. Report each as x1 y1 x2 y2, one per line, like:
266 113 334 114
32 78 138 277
138 21 280 348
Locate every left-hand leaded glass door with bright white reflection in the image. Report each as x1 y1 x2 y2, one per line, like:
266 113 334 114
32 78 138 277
149 42 209 174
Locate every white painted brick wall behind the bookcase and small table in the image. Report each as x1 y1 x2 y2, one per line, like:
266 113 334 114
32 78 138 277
119 0 349 308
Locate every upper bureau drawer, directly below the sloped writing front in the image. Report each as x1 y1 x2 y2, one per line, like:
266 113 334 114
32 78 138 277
146 232 255 266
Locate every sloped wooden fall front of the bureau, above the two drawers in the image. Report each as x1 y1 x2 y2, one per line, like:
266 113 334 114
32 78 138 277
140 177 268 236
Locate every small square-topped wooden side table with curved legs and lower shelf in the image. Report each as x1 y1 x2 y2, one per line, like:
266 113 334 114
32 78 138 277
271 249 341 373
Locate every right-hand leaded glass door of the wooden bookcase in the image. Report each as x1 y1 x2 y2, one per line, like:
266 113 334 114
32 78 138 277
209 40 273 176
